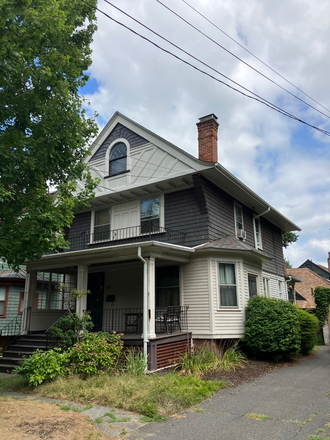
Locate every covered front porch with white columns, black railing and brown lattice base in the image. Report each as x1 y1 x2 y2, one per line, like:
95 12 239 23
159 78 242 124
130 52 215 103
24 241 194 369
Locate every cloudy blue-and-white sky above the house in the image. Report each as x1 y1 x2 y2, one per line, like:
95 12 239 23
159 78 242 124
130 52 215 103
82 0 330 267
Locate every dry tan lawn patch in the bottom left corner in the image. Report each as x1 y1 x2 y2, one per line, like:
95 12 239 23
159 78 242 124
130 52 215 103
0 397 110 440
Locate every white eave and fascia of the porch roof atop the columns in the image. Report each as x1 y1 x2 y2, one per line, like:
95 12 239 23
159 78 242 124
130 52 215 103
26 241 195 271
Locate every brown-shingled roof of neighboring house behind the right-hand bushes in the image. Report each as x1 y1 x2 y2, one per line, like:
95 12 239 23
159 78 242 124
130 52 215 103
286 268 330 310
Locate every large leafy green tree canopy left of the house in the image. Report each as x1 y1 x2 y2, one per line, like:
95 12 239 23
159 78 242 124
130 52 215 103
0 0 97 268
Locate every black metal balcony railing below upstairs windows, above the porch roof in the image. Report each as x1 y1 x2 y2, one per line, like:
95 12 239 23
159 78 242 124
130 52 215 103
48 224 186 253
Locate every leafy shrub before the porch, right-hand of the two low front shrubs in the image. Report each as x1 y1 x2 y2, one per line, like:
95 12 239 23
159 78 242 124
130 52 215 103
68 333 122 377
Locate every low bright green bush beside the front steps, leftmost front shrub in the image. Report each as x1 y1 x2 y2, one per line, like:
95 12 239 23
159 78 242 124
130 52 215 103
14 348 69 387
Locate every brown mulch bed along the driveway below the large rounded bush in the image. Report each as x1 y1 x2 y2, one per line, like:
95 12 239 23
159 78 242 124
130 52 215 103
204 354 314 387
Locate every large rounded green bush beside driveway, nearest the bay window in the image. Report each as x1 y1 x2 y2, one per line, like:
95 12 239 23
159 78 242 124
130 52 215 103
243 296 301 361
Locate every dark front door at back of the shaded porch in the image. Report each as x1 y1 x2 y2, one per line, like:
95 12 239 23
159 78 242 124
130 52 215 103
87 272 104 332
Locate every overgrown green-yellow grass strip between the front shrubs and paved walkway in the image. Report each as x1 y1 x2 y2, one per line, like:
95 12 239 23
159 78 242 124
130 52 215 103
0 373 226 419
